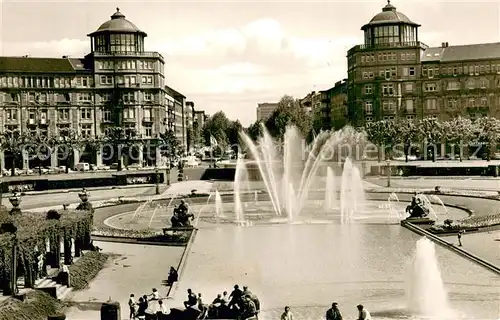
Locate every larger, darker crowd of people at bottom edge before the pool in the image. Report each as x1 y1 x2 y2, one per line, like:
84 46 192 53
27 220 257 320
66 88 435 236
184 285 260 320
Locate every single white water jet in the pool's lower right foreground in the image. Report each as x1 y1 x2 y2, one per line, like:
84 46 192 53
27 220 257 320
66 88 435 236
406 238 450 318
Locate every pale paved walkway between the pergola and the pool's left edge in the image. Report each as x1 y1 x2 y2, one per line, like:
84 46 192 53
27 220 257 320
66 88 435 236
66 241 184 320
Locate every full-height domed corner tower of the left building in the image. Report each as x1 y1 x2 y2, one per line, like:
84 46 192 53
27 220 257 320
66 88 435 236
85 8 167 165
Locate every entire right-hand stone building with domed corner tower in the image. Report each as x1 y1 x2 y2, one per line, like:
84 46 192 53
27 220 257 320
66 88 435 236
347 1 500 125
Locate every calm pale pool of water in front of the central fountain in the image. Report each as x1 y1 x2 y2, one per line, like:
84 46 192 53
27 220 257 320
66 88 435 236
174 224 500 319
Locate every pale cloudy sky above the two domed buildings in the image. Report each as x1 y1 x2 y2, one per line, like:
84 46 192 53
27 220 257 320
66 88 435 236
0 0 500 126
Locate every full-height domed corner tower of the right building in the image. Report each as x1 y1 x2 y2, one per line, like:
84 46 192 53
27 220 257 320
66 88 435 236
347 0 428 125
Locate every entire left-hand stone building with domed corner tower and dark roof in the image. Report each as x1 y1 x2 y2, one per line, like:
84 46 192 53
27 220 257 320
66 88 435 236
0 8 195 169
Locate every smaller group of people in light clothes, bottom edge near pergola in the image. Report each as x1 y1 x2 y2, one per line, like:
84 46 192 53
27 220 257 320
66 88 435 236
128 288 170 320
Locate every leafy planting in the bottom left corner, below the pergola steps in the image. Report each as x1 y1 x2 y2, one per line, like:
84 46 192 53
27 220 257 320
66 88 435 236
0 290 63 320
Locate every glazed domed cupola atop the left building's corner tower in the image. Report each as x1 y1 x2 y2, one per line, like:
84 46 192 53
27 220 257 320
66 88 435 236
88 8 147 54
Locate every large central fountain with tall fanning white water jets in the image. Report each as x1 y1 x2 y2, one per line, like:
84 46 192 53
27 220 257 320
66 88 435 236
239 126 364 220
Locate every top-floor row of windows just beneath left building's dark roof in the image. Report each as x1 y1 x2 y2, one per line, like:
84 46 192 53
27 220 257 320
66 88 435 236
0 76 94 88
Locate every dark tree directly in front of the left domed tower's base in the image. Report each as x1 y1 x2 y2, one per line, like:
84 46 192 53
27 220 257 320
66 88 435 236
104 127 139 171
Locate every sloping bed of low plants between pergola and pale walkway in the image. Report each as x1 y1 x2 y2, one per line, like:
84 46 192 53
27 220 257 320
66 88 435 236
69 251 109 290
